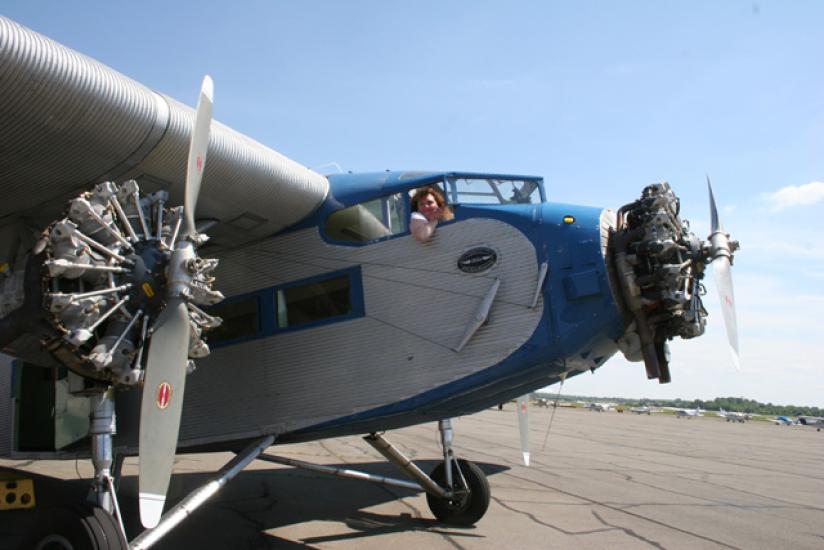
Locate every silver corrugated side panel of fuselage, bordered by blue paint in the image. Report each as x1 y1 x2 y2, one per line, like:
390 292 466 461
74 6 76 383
181 219 543 445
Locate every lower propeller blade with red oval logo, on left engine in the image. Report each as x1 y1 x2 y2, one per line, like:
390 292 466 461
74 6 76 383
139 297 189 528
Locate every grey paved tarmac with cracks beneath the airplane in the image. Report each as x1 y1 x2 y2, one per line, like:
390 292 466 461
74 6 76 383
0 404 824 550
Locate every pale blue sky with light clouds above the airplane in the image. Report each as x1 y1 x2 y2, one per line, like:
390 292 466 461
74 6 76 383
2 0 824 407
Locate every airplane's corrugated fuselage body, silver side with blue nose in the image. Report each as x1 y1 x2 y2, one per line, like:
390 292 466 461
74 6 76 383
145 178 623 446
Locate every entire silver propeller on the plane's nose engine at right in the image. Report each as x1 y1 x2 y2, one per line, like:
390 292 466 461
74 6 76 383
707 176 741 371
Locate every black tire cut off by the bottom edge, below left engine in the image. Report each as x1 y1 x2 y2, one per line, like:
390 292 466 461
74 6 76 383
20 505 129 550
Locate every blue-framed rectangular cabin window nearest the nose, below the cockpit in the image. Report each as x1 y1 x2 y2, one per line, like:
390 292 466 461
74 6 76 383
276 274 352 328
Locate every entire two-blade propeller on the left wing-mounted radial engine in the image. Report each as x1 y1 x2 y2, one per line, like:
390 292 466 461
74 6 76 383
139 76 213 528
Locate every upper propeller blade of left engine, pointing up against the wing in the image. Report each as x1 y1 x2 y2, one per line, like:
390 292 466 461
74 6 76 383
183 75 214 238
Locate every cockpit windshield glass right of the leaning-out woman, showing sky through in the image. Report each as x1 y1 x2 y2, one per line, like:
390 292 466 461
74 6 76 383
446 177 541 204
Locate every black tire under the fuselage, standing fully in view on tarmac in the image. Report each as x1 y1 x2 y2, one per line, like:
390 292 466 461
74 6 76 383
426 460 491 527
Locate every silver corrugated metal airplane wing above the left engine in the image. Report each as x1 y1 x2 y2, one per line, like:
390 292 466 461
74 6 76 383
0 16 329 254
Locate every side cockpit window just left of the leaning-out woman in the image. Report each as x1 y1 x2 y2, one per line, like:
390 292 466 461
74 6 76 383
324 193 407 243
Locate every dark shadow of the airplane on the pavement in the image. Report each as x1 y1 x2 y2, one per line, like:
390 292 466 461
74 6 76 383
0 460 508 550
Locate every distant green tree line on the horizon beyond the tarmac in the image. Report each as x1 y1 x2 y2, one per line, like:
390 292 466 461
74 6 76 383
540 393 824 416
